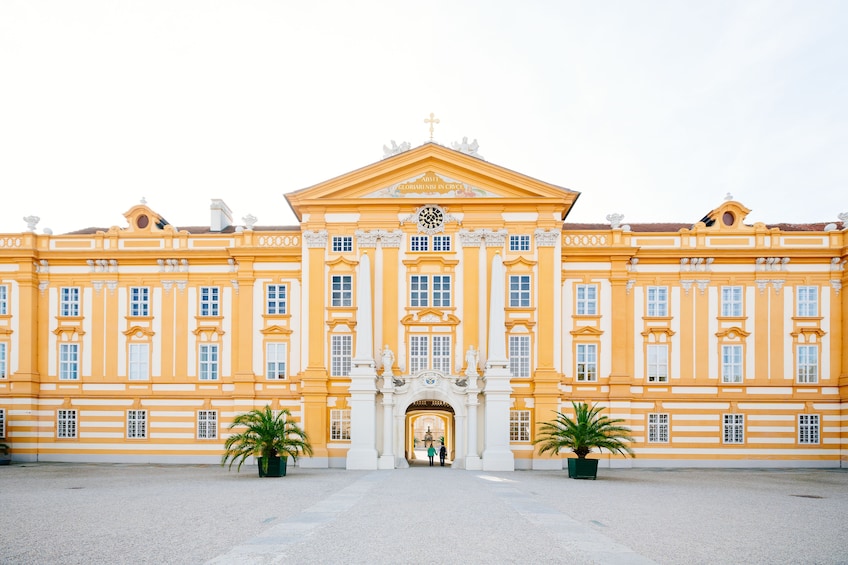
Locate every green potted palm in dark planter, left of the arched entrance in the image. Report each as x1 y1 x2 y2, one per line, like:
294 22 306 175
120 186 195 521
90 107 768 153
221 405 312 477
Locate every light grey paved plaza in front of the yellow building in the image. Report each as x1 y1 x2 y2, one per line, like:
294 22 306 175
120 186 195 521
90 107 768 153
0 463 848 565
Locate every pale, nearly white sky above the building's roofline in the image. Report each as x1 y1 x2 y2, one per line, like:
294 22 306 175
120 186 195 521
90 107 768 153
0 0 848 233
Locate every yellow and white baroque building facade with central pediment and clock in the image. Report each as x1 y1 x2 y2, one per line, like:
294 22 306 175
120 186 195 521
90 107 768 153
0 143 848 471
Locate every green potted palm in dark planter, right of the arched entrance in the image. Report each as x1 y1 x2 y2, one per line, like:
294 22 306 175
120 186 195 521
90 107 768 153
533 401 636 479
